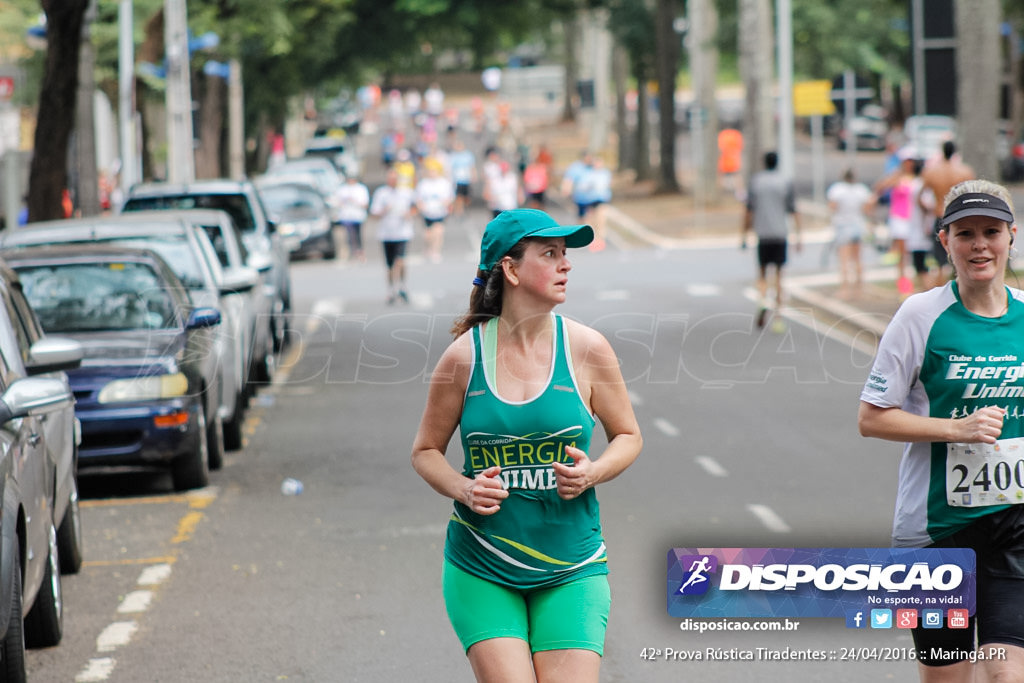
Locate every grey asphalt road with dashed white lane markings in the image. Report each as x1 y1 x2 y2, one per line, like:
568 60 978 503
22 188 937 683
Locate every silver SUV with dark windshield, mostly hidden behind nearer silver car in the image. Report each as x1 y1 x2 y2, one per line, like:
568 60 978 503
122 179 292 351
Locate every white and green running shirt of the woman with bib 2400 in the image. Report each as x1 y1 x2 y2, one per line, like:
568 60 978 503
860 282 1024 547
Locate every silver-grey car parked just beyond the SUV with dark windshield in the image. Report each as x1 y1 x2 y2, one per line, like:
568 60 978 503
256 176 338 259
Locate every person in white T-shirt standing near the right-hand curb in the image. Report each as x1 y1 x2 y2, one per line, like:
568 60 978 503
825 168 874 299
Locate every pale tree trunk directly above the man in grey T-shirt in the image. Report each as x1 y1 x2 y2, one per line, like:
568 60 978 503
739 0 775 192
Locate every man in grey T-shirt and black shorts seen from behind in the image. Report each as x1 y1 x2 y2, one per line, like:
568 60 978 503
740 152 802 328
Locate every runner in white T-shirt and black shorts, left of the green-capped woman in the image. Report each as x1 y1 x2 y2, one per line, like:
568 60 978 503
370 168 416 304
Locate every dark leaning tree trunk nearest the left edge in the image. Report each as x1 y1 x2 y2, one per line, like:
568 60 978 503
29 0 89 221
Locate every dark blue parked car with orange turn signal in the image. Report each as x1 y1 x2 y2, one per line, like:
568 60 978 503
6 244 220 490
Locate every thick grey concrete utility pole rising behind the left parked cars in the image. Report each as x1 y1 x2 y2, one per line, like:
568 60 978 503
164 0 196 182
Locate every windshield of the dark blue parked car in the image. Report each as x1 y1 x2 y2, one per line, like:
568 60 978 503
16 261 178 333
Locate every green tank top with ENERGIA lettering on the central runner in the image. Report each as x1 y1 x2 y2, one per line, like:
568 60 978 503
444 315 607 590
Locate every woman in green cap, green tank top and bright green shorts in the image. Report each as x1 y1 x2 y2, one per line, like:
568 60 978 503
413 209 642 682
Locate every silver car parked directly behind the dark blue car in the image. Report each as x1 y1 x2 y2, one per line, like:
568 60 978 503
0 211 247 462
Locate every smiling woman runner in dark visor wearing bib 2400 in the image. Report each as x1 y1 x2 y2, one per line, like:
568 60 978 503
857 180 1024 683
